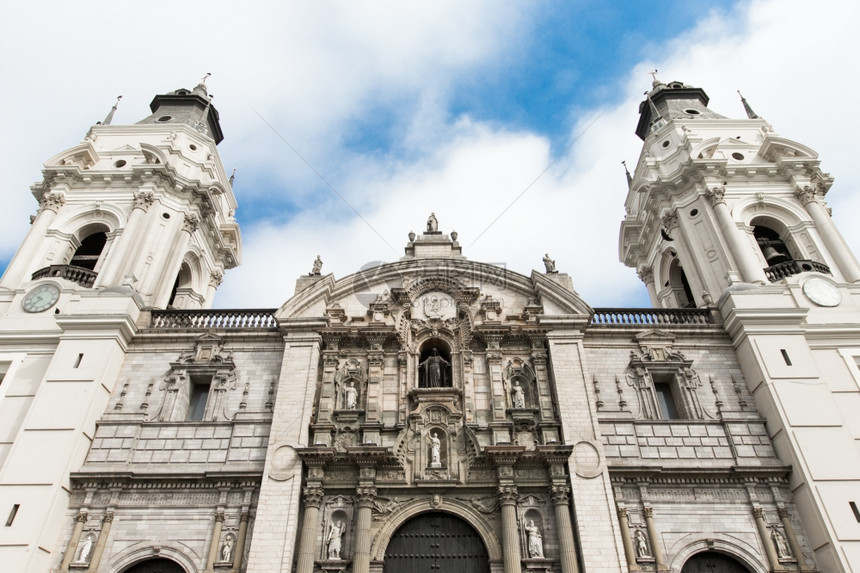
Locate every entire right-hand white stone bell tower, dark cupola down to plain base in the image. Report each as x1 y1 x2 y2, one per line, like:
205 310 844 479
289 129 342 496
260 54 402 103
619 80 860 571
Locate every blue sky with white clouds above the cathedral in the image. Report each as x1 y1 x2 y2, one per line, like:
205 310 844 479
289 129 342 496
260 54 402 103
0 0 860 307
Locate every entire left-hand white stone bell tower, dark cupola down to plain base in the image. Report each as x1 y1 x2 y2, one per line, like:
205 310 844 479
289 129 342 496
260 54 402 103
0 83 241 572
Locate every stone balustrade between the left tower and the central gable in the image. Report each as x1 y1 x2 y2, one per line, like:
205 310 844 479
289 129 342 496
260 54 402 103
149 308 278 330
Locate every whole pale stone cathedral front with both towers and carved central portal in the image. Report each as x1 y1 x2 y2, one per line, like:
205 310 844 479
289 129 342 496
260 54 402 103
0 81 860 573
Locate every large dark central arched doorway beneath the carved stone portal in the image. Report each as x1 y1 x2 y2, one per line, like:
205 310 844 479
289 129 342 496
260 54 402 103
383 513 490 573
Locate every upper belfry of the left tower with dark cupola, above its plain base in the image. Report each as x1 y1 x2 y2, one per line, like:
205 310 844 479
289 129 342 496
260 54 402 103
0 82 241 309
